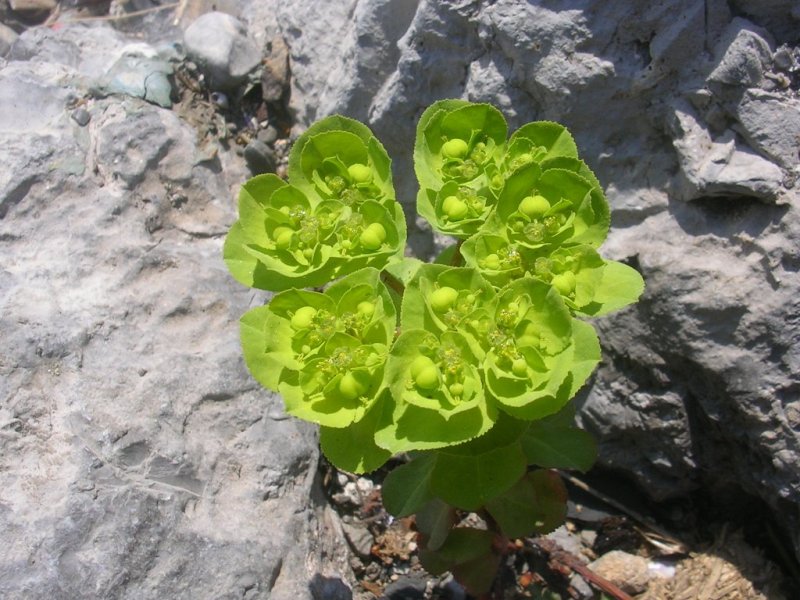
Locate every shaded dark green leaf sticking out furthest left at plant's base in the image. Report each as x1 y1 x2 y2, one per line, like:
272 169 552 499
381 453 436 517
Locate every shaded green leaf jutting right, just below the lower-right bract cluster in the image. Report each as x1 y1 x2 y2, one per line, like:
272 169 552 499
522 422 597 472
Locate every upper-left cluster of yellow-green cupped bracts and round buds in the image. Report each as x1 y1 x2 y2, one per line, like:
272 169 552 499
224 117 406 291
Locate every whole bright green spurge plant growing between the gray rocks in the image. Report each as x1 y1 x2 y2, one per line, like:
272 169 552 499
224 100 644 593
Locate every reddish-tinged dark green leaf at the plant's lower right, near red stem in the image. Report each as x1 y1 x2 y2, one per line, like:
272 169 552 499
486 470 567 538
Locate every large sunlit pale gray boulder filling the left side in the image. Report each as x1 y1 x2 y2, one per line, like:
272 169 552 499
0 24 349 600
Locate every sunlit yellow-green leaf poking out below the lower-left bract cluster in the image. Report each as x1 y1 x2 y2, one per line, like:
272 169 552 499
319 396 392 473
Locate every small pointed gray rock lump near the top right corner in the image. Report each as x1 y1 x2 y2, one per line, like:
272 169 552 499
707 18 772 87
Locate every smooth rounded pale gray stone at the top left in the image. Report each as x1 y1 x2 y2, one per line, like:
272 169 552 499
183 12 261 90
